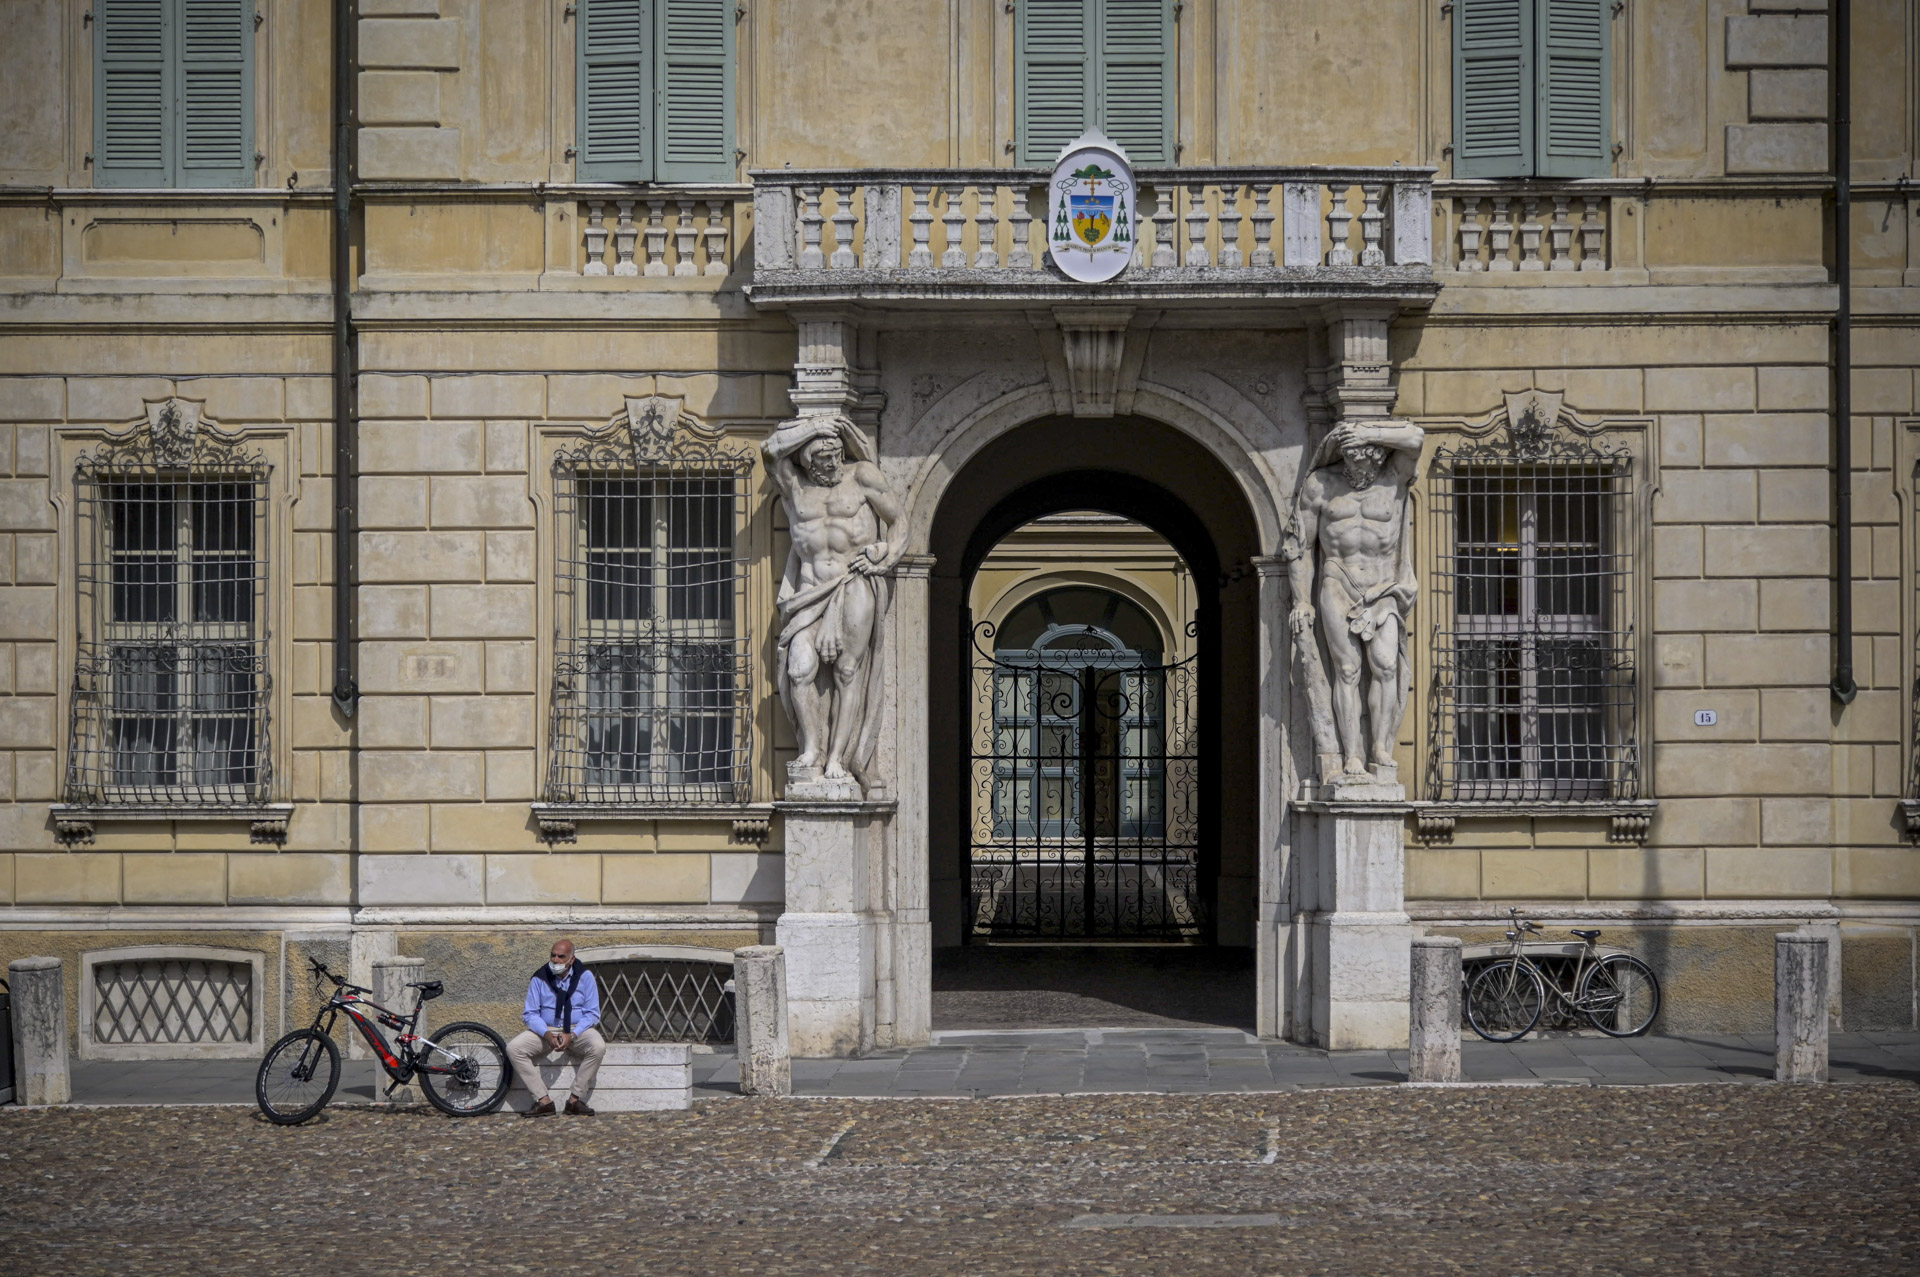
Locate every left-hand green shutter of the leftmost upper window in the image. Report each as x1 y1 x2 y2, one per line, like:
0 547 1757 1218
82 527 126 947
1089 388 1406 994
94 0 173 186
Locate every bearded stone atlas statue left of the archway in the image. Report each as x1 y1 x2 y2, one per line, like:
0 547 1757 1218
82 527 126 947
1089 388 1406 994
764 413 906 799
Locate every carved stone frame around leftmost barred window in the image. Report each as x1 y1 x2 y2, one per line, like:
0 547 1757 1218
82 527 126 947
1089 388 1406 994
48 396 300 845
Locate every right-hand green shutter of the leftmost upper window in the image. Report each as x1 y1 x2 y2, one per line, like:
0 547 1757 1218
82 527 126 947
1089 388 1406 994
175 0 253 186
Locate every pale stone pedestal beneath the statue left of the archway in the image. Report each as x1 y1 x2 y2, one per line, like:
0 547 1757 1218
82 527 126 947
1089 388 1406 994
774 798 893 1058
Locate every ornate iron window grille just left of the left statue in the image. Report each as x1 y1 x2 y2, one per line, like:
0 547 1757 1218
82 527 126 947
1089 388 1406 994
547 407 753 805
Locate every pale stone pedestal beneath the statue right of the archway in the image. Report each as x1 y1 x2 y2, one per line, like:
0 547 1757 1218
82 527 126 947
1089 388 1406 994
1294 783 1413 1050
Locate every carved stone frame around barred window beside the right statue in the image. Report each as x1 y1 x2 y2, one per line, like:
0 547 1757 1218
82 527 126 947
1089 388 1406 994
1409 390 1661 845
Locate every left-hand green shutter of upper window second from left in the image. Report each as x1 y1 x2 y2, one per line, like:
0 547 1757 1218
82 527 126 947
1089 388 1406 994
576 0 653 182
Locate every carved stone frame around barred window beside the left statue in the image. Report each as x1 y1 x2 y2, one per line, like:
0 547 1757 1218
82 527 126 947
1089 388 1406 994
528 394 791 847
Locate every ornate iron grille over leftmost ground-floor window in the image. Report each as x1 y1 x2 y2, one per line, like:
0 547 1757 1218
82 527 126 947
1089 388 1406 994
65 403 273 807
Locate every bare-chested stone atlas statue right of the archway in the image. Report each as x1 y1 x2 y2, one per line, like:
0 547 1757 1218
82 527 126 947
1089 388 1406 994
1281 421 1425 797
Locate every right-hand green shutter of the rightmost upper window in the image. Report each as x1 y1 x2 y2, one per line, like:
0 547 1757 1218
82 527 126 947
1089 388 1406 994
1534 0 1613 177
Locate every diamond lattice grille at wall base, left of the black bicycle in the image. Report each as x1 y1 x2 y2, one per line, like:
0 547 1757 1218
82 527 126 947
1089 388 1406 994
94 958 253 1047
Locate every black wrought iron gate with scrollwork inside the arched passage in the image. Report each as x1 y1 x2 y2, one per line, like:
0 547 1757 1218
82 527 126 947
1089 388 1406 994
966 624 1206 941
